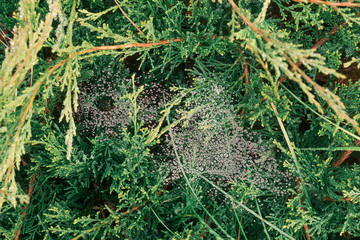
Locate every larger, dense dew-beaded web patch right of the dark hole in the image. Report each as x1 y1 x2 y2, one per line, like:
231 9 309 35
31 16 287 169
158 77 293 201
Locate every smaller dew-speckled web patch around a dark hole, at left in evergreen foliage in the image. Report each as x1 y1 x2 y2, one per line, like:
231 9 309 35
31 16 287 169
77 66 171 138
